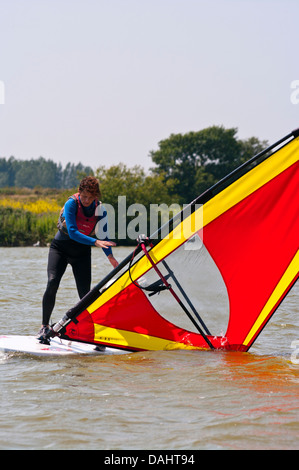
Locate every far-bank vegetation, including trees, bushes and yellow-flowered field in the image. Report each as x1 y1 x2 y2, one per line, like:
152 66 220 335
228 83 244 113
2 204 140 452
0 126 267 246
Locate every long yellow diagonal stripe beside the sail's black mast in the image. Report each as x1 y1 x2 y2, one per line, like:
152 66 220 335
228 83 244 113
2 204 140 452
87 137 299 313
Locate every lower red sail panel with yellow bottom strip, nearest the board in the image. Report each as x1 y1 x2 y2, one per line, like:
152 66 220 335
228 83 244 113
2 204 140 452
64 283 225 350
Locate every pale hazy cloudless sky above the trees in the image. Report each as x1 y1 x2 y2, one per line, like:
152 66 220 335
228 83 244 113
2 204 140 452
0 0 299 170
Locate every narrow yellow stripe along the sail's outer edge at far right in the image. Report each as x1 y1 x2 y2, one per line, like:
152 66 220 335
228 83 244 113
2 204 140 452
243 250 299 346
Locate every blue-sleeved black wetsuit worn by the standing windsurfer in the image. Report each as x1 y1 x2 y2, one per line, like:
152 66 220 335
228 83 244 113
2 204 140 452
43 196 112 325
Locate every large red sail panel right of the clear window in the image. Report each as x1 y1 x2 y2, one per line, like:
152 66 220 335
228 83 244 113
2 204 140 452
204 150 299 349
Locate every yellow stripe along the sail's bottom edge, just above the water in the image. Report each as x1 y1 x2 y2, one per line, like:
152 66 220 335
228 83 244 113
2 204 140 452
94 324 199 351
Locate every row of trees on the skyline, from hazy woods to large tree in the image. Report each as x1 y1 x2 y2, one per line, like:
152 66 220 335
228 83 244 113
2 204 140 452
0 126 268 199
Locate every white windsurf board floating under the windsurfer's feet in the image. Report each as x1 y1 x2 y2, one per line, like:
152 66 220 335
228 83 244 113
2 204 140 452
0 335 127 356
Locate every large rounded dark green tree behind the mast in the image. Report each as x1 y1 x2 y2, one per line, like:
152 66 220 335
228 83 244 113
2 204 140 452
150 126 266 203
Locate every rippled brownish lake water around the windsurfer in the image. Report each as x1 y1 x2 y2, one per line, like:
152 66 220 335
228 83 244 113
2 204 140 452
0 244 299 450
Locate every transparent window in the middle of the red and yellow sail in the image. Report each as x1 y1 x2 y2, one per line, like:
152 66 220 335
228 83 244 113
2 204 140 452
138 234 229 336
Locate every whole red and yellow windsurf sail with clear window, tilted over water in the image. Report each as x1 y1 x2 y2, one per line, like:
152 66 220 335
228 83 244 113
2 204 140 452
54 131 299 351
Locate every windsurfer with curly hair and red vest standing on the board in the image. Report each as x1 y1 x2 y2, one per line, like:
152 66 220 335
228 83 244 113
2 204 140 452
38 176 118 341
